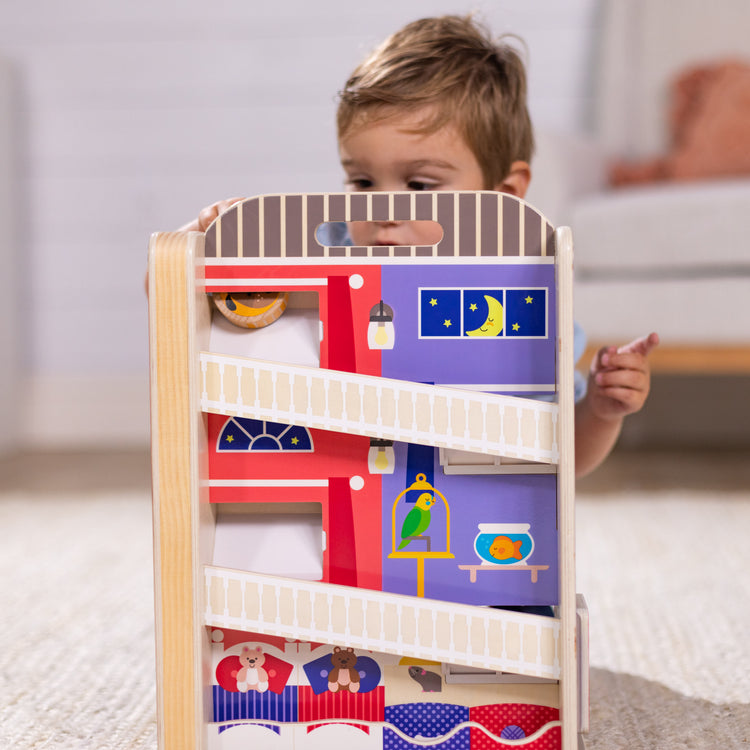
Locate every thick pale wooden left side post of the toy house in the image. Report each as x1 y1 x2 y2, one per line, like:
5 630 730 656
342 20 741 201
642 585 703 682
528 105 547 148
149 232 214 749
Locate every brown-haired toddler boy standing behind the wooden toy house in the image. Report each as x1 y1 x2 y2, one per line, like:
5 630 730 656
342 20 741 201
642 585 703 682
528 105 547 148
183 16 659 476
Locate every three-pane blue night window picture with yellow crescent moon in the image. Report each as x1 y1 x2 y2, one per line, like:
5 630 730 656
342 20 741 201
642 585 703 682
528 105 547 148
419 288 548 339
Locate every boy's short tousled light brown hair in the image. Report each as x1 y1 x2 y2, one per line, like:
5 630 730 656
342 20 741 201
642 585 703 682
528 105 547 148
337 16 534 189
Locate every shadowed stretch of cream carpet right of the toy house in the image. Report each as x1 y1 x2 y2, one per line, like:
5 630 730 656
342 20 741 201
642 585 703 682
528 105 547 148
577 492 750 750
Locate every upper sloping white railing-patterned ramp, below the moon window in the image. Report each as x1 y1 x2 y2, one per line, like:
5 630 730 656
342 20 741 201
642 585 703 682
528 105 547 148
200 352 560 464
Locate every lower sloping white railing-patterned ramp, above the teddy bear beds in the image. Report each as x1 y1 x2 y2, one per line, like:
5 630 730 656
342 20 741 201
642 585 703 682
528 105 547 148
204 566 560 679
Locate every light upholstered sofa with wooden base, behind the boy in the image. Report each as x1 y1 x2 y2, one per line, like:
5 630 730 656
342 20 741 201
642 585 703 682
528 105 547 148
528 0 750 375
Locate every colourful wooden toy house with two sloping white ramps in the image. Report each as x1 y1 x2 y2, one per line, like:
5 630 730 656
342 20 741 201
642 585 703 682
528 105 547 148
149 192 587 750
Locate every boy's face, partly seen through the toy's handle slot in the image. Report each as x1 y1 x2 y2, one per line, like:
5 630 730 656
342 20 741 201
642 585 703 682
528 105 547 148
339 111 488 246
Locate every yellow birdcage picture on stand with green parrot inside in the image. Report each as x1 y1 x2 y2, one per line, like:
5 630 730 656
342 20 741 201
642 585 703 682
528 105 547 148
388 474 455 597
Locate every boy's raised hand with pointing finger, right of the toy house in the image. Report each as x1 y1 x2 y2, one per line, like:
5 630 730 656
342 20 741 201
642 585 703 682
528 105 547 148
588 333 659 419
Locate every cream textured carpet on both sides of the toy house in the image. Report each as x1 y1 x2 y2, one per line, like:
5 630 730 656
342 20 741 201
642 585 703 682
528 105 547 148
0 491 750 750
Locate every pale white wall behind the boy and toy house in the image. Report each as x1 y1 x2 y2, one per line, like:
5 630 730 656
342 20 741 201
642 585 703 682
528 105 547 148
0 0 596 446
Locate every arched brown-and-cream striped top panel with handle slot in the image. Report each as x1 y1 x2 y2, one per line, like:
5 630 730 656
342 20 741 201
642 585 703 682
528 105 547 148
205 191 555 264
